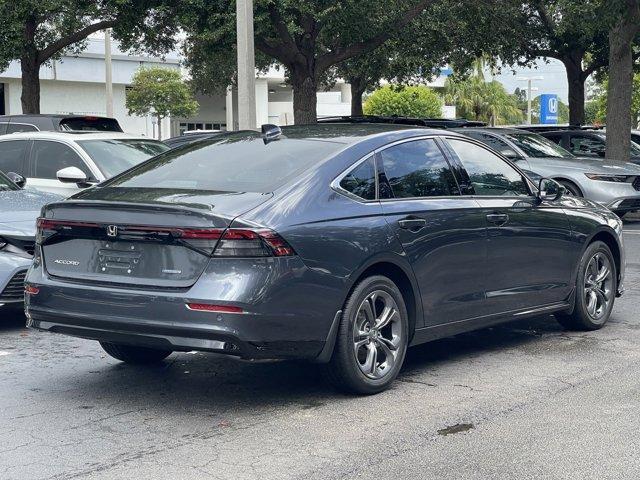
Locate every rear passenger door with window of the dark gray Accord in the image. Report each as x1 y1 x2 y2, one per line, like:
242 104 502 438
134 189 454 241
377 138 486 327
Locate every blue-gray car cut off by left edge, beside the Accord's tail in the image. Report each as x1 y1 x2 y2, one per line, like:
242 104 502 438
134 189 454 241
0 172 63 310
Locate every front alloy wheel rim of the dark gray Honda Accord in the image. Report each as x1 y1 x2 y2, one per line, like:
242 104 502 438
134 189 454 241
584 252 613 321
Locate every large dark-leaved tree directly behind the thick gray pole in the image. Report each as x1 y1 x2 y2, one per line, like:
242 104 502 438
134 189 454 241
179 0 480 123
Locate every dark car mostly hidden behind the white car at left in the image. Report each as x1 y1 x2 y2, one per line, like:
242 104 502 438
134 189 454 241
0 114 122 135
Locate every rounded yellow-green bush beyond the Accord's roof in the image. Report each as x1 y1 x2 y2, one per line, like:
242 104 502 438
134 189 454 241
364 85 442 118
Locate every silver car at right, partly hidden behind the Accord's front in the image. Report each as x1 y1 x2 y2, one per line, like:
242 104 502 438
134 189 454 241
458 127 640 216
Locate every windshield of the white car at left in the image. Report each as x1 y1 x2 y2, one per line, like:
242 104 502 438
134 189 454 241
78 139 169 178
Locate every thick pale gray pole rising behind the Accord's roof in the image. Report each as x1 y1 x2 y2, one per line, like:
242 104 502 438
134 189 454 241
236 0 257 130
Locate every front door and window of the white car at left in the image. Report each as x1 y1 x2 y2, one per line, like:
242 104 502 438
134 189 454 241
27 140 96 196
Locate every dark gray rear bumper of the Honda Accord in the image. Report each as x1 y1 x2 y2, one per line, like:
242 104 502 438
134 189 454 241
25 258 342 359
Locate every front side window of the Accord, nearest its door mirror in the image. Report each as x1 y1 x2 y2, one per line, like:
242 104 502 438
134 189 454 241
449 139 529 196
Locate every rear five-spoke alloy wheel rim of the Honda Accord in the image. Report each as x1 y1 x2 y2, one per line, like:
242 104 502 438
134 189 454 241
353 290 404 380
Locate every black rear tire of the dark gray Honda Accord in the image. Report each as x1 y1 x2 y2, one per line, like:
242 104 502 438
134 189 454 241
322 275 409 395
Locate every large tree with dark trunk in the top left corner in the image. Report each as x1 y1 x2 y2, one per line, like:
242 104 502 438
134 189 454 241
0 0 177 113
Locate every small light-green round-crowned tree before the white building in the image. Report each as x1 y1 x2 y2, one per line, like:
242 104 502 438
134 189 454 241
127 67 198 139
